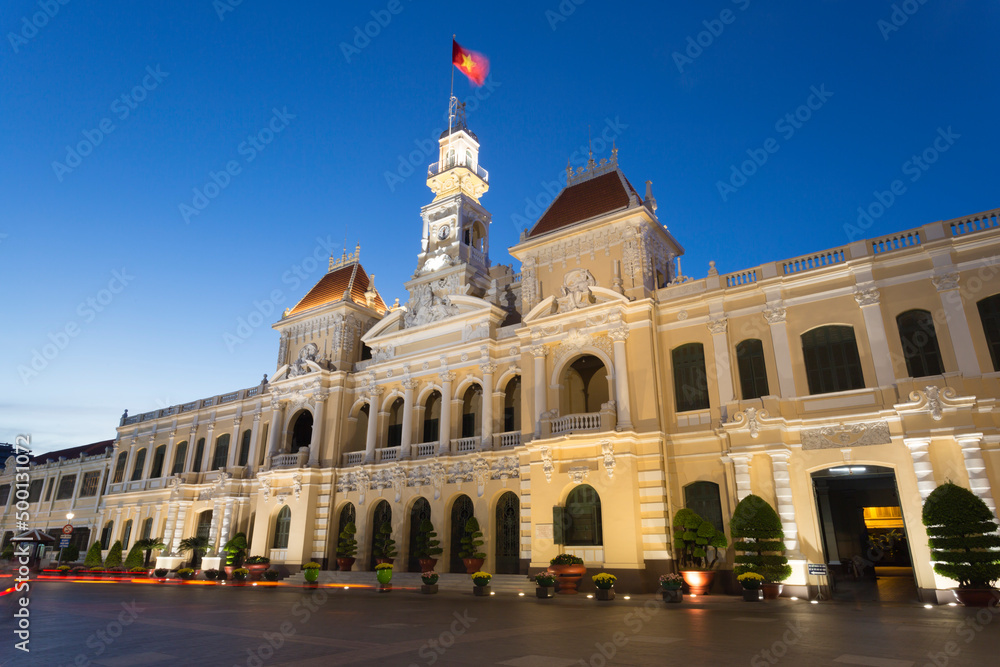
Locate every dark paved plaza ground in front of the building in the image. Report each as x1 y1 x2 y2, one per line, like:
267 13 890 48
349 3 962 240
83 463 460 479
0 579 1000 667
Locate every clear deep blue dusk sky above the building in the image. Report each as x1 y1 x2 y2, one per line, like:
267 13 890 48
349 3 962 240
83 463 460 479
0 0 1000 451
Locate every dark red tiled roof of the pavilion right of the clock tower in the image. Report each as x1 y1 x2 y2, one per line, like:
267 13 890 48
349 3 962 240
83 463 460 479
528 169 638 238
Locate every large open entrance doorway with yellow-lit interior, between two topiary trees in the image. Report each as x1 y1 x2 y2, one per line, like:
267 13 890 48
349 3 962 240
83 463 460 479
812 465 919 602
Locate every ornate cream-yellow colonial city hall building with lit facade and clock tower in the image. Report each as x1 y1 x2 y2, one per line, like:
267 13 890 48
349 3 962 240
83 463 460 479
0 108 1000 600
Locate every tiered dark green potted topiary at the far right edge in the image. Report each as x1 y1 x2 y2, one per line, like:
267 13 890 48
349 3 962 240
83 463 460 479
923 482 1000 607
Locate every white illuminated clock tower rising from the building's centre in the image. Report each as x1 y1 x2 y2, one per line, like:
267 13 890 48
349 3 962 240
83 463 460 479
405 98 491 326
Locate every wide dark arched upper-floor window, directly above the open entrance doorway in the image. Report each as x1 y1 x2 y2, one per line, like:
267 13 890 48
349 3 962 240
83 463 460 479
802 325 865 394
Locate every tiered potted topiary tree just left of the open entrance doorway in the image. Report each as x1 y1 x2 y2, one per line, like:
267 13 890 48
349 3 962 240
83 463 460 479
729 493 792 600
